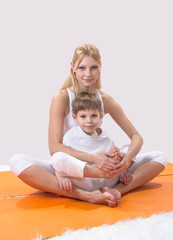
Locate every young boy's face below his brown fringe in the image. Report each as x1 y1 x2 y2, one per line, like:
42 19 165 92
73 109 102 135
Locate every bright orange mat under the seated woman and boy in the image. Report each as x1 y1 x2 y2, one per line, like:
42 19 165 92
0 164 173 240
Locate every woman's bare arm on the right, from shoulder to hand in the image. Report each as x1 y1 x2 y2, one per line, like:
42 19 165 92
102 92 143 173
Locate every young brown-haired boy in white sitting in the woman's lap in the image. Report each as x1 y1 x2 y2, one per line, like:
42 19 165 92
51 92 132 192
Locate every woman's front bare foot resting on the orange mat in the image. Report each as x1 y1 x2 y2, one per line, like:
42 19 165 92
88 190 117 207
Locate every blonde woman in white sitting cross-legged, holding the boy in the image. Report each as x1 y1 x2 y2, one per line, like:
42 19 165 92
10 44 166 207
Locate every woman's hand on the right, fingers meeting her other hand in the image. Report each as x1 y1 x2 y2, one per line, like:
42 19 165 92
111 153 133 175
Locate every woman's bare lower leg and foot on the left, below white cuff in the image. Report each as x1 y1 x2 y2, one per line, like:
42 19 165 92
19 165 116 207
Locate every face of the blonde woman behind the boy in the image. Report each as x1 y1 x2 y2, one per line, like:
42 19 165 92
74 55 101 87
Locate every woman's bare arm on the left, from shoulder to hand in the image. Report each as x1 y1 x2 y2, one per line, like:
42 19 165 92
49 90 115 171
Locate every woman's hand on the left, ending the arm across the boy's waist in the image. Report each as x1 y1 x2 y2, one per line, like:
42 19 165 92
93 152 119 172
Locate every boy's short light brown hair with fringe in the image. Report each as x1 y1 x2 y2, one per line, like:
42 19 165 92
72 92 102 115
